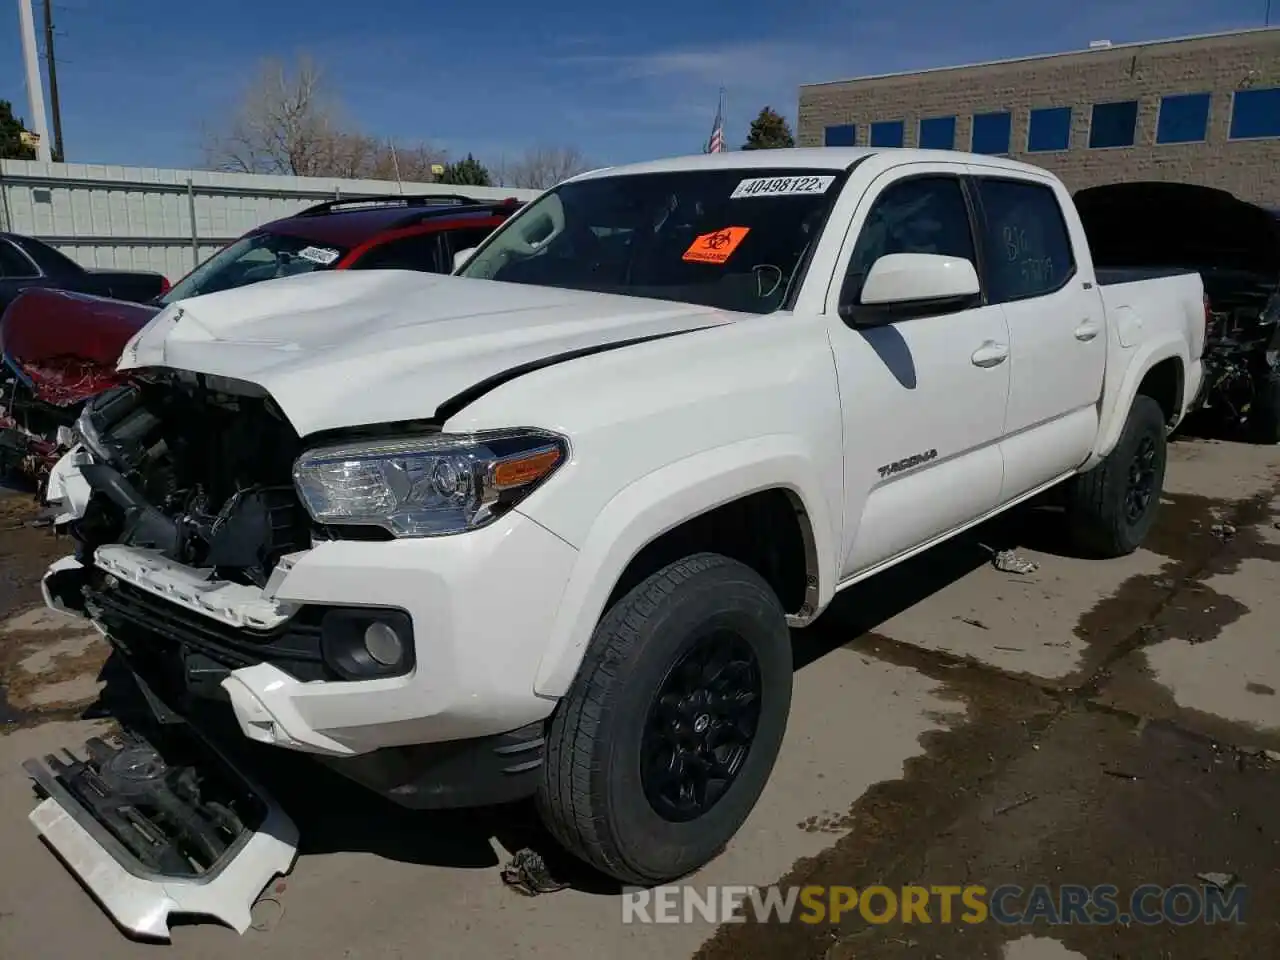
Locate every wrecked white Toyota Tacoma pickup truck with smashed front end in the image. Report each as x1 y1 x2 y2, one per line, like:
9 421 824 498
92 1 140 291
35 148 1204 931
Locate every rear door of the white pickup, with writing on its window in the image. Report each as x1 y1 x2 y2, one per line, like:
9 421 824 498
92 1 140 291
970 175 1107 500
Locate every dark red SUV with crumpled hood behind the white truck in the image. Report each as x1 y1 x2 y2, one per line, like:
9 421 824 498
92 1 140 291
0 195 524 481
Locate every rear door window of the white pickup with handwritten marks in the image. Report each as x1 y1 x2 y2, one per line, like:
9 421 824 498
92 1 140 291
978 179 1075 303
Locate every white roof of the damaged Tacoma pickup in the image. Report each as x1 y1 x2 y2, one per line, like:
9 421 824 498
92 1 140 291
573 147 1064 180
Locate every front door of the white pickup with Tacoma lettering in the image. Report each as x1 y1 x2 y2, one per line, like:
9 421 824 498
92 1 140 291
831 164 1009 579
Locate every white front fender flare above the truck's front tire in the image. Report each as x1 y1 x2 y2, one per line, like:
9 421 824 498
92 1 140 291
534 435 837 699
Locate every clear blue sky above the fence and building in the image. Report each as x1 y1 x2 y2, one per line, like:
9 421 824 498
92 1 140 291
0 0 1280 166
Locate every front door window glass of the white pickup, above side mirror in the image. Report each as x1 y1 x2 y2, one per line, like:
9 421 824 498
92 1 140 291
844 177 974 302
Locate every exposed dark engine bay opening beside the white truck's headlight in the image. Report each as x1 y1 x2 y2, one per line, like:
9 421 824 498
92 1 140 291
72 375 311 586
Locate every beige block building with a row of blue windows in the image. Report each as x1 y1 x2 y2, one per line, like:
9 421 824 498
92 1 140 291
799 27 1280 207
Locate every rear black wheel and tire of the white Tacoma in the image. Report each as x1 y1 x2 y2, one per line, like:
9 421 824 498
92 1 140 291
1066 394 1169 558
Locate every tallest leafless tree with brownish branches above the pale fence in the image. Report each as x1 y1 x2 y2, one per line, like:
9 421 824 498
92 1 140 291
197 56 444 182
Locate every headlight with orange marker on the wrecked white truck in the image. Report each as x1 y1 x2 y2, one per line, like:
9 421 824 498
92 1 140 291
293 430 568 536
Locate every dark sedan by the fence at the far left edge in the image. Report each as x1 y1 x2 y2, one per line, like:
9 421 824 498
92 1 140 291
0 233 169 311
